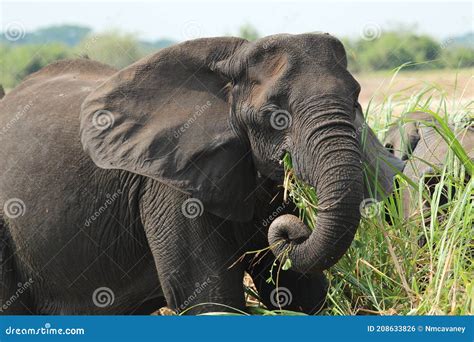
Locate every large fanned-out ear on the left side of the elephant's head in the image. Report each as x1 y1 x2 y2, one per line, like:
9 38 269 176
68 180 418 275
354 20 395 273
81 38 255 221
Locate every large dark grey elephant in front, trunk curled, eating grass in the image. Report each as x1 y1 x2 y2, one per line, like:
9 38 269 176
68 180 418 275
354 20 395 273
0 34 402 314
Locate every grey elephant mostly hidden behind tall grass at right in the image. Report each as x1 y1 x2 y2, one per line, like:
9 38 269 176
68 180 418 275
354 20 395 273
385 112 474 218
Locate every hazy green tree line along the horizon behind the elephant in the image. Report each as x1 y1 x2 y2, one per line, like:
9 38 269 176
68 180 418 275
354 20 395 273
0 25 474 88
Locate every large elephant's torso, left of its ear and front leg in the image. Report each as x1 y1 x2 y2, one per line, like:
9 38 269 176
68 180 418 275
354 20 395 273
0 60 161 311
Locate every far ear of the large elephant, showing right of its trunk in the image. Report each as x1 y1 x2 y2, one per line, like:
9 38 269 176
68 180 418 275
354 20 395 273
355 104 405 199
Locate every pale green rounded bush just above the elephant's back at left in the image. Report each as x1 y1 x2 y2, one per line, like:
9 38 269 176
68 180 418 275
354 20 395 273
75 31 144 68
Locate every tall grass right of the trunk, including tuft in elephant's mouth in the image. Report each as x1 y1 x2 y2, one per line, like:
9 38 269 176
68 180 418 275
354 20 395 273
284 77 474 315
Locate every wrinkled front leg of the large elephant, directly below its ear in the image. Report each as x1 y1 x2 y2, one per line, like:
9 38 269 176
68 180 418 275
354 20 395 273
141 182 245 314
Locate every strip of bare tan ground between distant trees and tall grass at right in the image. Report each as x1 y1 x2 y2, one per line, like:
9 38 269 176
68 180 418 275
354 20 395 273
354 68 474 108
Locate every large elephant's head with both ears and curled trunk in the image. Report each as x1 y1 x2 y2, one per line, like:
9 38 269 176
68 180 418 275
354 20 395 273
81 34 402 272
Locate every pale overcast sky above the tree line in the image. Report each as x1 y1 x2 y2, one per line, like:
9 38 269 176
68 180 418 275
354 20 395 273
0 0 473 40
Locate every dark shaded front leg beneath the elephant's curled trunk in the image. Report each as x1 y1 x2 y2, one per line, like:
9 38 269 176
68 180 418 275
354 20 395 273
248 255 328 314
